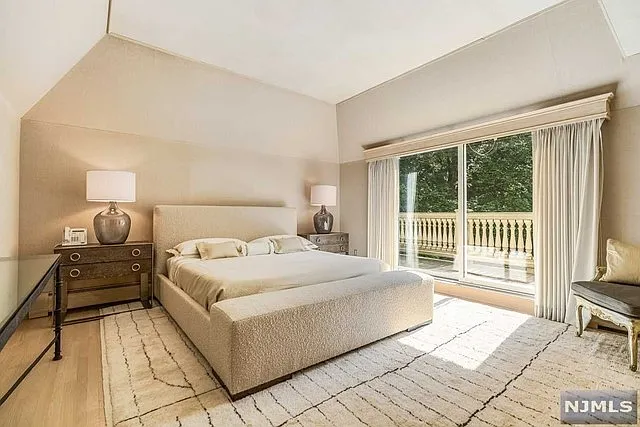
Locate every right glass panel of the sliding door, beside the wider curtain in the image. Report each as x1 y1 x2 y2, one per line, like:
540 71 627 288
463 133 534 292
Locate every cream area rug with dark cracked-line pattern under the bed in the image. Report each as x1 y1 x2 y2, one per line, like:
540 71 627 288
101 298 640 427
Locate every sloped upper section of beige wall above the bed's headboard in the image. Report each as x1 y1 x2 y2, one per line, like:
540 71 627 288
26 36 338 163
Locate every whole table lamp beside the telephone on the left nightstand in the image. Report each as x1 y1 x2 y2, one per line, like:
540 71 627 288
87 171 136 245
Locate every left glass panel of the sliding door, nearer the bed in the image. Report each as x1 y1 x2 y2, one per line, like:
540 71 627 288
399 147 461 280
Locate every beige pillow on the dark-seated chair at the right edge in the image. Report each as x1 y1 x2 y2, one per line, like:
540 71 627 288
602 239 640 285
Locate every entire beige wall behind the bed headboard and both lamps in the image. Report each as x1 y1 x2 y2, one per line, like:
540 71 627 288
20 36 340 254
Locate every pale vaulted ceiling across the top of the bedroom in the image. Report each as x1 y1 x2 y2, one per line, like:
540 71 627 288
0 0 640 116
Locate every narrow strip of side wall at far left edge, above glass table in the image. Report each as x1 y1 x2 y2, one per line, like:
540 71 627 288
0 93 20 256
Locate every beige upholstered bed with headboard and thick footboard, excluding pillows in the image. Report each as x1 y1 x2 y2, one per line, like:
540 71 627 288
153 205 433 399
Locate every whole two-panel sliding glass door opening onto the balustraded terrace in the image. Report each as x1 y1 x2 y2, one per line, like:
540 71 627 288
399 133 534 293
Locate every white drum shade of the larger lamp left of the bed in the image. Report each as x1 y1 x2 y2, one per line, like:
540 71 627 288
87 171 136 202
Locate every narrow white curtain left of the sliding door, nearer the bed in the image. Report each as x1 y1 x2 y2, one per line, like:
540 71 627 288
367 158 400 268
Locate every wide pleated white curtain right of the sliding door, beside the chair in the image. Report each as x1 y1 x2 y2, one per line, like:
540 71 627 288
533 119 604 323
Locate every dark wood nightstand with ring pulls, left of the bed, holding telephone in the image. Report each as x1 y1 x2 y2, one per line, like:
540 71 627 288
54 242 153 313
